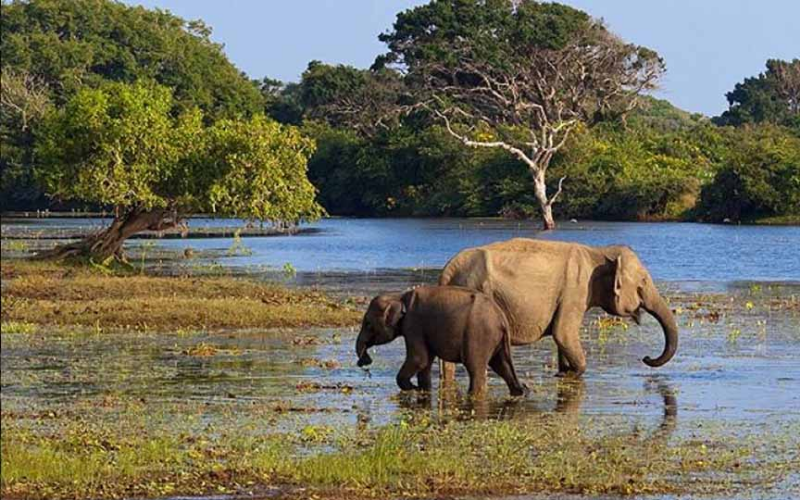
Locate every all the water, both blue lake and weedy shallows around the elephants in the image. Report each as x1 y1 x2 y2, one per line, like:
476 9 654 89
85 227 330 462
0 219 800 498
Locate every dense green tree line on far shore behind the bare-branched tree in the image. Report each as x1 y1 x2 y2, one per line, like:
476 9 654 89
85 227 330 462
278 51 800 222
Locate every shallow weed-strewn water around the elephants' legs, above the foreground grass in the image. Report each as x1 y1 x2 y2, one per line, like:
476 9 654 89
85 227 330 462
0 286 800 426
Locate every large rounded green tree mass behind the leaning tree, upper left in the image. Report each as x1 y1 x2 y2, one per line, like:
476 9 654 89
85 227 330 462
0 0 264 207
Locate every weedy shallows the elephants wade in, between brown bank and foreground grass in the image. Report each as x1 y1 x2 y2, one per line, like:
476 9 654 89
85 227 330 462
0 286 800 499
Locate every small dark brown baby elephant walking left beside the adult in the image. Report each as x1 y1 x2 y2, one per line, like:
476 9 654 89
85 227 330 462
356 286 525 396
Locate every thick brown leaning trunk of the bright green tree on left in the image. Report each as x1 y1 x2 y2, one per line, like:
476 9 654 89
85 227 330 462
34 208 177 261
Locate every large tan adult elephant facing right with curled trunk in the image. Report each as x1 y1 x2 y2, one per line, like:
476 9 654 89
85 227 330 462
439 238 678 380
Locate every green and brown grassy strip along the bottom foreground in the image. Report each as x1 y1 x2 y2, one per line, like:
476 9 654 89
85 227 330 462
1 415 800 499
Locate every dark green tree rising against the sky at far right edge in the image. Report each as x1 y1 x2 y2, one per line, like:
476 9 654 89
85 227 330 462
714 59 800 130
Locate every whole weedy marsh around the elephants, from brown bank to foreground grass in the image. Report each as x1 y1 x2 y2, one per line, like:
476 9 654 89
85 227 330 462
2 241 800 499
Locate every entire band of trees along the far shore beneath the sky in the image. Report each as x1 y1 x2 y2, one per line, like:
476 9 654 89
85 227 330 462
0 0 800 227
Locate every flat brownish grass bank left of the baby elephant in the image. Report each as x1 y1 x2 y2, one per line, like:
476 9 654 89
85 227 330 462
2 261 360 332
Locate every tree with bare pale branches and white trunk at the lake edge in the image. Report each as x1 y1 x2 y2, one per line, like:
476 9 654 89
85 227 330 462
407 26 664 229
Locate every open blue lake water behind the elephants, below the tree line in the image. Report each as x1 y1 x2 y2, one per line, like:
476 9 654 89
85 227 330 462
3 218 800 285
